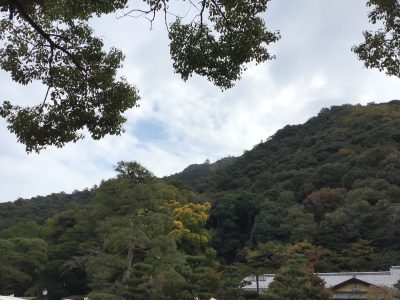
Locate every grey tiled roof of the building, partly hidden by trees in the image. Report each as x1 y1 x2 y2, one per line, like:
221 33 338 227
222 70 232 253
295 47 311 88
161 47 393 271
243 266 400 290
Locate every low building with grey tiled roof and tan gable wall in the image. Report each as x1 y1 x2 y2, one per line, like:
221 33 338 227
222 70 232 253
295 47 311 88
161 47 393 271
243 266 400 300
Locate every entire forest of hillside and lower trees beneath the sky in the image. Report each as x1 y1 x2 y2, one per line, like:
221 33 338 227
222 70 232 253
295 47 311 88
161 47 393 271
0 100 400 299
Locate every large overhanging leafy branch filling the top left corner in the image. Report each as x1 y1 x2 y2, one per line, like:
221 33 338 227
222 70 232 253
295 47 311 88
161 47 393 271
0 0 139 152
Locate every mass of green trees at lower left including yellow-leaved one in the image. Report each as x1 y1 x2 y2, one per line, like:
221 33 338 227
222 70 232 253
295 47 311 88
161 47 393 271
0 162 225 300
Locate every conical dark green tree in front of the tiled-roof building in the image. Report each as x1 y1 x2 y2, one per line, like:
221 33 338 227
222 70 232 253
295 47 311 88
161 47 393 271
265 255 329 300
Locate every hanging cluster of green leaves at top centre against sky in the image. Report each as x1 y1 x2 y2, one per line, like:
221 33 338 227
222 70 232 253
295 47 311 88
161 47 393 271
169 0 279 88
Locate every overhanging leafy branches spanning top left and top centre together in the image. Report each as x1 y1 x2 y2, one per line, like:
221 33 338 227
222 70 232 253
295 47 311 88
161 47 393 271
0 0 279 152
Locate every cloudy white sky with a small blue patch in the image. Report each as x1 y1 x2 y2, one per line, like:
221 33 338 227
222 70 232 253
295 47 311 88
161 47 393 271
0 0 400 202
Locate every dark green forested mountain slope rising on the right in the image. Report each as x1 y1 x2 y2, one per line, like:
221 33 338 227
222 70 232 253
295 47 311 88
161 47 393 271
173 101 400 269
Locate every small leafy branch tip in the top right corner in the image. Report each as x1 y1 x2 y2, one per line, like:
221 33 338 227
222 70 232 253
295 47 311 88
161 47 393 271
353 0 400 77
